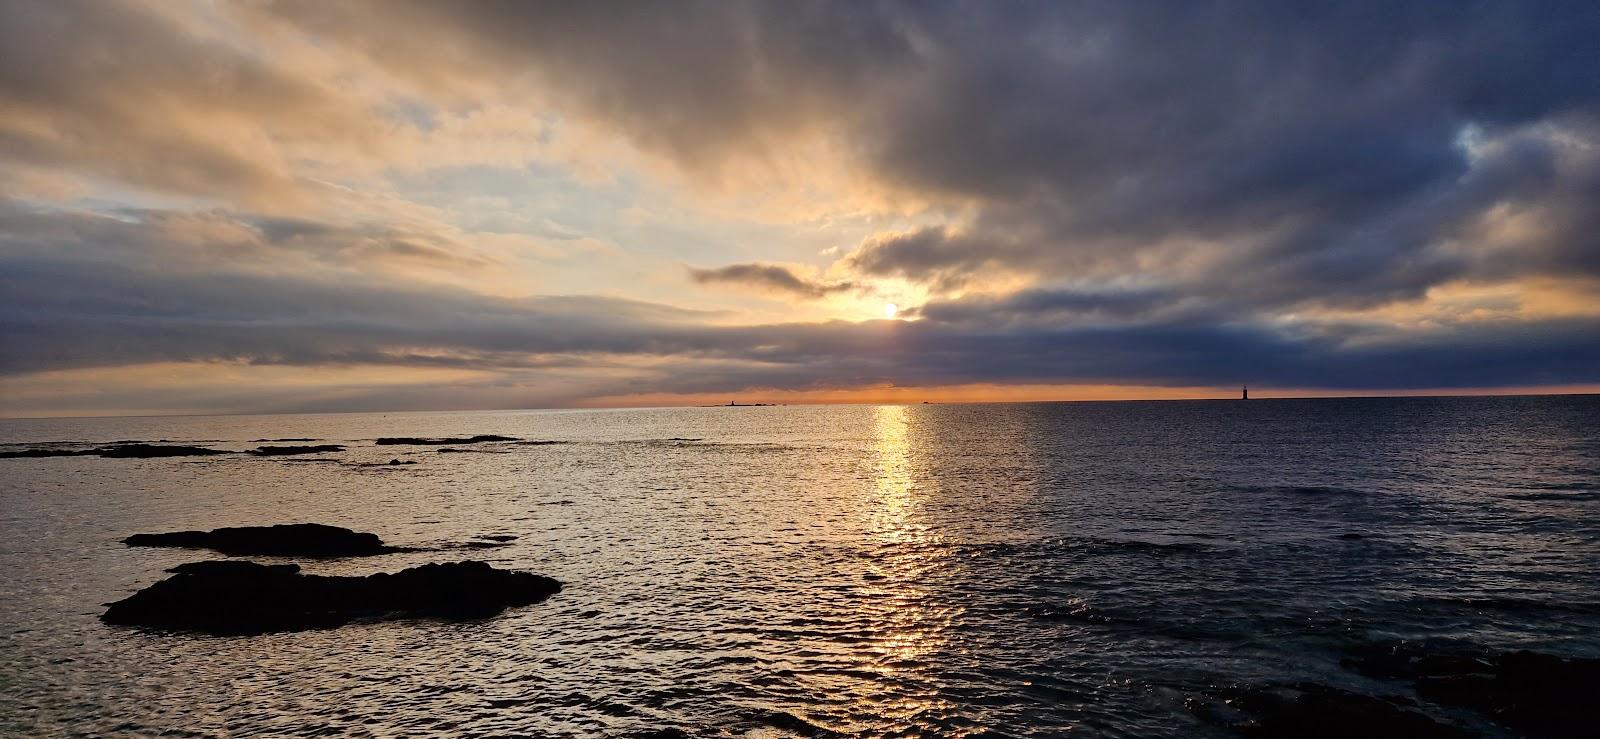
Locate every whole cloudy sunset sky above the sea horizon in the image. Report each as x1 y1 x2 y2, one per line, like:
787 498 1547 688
0 0 1600 416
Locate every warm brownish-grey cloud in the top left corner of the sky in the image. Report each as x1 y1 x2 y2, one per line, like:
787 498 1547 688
0 0 381 208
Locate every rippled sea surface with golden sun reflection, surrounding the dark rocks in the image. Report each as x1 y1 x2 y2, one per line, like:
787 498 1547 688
0 397 1600 737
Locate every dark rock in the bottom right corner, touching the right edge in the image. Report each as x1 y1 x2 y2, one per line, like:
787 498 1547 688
1341 645 1600 737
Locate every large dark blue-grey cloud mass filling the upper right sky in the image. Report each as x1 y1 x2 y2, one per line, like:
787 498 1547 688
259 0 1600 307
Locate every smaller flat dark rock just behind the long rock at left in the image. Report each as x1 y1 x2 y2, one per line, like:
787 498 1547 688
122 523 405 557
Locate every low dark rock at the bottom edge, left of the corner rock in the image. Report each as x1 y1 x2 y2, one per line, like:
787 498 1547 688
1189 683 1474 739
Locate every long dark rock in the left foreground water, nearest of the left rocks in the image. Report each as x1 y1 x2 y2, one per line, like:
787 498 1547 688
101 561 562 635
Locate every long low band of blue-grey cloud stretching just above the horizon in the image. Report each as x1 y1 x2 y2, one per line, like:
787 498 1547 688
0 204 1600 398
